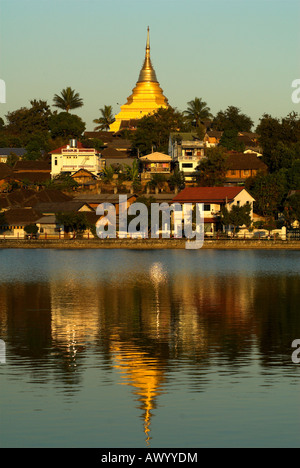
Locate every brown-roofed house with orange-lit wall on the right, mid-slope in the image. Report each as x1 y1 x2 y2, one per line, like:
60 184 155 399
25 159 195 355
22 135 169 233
226 152 268 185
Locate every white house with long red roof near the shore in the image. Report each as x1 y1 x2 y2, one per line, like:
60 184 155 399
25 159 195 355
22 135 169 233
173 187 255 234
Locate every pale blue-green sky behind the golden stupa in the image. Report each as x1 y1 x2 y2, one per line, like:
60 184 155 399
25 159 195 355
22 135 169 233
0 0 300 130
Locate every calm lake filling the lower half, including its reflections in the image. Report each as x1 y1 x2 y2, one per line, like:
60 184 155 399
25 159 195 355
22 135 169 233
0 249 300 448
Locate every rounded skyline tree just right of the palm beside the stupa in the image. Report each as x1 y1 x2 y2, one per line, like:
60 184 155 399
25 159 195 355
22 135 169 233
212 106 253 132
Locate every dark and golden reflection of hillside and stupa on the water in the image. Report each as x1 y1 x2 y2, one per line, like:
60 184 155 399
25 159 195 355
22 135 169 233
0 252 300 445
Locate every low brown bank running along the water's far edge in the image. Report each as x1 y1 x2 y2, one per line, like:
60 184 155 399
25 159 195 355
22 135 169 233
0 239 300 250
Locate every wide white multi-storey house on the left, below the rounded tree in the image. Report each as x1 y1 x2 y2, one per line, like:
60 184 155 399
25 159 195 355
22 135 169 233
50 140 101 178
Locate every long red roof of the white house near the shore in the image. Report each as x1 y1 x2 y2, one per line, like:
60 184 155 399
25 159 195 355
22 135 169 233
173 187 244 203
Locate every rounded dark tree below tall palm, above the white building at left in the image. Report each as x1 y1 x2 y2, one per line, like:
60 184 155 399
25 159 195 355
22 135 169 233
49 112 85 140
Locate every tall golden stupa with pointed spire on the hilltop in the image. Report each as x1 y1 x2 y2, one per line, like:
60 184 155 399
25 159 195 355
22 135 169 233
110 26 168 132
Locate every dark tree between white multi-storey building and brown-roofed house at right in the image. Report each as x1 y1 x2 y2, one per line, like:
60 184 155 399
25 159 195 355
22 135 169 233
196 147 228 187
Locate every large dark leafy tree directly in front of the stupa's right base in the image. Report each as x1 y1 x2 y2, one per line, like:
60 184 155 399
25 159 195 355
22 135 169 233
132 107 187 155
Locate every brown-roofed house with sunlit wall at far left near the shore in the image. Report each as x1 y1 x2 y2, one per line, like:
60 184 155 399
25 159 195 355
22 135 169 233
0 208 41 239
